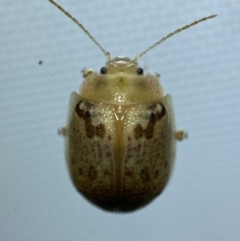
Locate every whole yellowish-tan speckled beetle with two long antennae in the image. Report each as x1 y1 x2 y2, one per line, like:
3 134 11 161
48 0 217 212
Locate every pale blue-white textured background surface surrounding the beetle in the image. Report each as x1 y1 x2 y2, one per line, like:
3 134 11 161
0 0 240 241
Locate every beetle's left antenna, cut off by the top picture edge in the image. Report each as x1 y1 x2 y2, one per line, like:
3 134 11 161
48 0 111 61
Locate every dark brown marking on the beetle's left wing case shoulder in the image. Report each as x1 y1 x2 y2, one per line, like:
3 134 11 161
75 101 106 139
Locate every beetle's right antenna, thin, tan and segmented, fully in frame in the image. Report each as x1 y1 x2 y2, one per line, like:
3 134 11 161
134 14 217 62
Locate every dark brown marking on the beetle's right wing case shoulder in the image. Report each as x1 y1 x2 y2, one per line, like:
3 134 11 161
134 103 166 140
